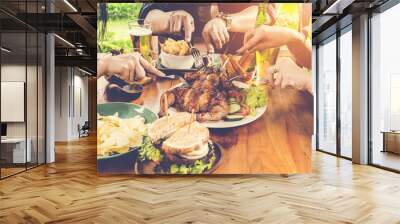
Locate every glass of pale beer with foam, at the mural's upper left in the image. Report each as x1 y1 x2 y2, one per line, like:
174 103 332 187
128 19 152 62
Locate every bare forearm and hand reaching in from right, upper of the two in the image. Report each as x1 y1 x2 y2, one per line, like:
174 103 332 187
237 25 298 54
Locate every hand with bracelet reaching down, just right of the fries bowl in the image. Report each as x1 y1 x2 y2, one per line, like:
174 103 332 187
202 18 229 53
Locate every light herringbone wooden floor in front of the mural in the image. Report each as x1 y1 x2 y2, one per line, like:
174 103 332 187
0 138 400 224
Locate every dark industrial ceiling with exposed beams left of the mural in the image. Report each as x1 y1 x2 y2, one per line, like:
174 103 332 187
0 0 97 73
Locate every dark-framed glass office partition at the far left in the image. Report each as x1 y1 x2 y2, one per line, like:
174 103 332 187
0 1 46 178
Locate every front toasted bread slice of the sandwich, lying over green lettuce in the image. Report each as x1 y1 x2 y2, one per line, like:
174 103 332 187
161 121 210 159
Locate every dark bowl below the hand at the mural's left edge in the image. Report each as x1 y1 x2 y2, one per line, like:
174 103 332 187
106 75 143 102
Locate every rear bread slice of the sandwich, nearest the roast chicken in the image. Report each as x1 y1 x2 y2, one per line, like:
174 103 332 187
148 112 196 143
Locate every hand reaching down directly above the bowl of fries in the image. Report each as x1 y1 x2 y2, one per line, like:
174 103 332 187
168 10 194 42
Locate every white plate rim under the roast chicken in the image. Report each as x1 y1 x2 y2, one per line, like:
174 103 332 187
168 106 267 128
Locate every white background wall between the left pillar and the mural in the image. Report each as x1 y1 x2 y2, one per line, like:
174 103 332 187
55 67 88 141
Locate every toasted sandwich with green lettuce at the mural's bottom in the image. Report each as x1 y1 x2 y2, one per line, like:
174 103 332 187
143 112 216 174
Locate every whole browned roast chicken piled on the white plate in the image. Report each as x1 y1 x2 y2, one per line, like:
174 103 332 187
159 54 254 122
